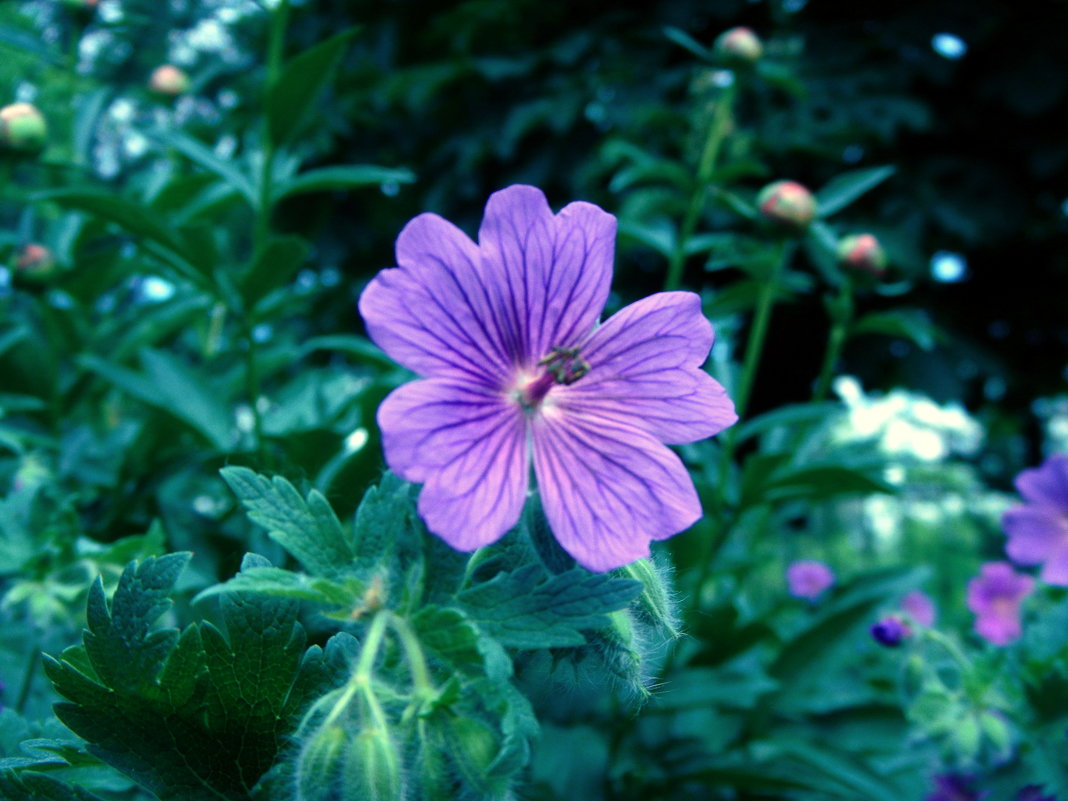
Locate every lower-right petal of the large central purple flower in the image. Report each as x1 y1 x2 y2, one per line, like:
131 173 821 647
533 408 701 570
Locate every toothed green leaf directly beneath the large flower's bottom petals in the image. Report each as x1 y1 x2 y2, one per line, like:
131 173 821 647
457 565 642 648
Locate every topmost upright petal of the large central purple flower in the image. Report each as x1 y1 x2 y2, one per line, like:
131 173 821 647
478 186 615 366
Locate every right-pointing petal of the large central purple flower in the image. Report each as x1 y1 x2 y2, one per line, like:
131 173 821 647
553 292 738 444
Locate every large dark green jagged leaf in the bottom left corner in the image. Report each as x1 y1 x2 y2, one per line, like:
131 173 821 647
46 554 352 801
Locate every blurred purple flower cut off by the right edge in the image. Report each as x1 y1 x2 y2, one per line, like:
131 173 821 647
1002 453 1068 586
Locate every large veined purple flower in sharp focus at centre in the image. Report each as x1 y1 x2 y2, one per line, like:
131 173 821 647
360 186 737 570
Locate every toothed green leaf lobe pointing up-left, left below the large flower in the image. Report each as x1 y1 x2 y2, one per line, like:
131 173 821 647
219 467 356 578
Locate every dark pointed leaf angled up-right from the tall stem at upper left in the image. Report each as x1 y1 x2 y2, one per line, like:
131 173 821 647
266 28 358 144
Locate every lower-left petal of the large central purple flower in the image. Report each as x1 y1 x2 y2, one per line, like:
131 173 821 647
378 378 529 551
